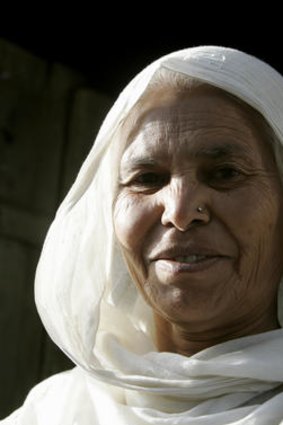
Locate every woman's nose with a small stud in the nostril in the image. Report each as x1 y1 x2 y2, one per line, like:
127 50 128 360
161 182 210 232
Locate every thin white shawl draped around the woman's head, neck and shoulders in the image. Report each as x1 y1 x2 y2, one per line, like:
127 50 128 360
3 46 283 425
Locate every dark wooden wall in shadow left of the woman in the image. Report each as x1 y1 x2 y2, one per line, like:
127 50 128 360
0 39 112 418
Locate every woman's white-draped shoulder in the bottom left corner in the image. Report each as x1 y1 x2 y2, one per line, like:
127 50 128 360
0 367 91 425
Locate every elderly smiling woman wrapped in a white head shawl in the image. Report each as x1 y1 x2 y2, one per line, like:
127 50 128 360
3 46 283 425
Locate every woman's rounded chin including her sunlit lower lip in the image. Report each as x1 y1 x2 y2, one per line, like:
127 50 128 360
145 259 235 325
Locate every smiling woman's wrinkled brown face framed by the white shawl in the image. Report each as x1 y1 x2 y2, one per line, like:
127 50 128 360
114 88 283 330
